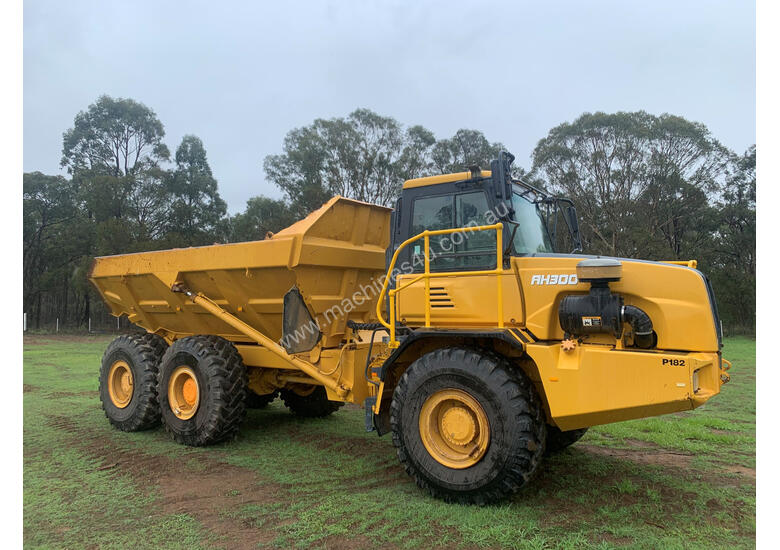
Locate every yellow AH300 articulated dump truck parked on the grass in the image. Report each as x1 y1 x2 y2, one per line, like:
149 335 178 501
90 153 729 503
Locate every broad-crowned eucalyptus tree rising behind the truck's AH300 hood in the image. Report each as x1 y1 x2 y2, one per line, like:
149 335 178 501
533 111 729 259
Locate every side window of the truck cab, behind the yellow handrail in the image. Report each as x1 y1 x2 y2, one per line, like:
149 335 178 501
410 191 496 272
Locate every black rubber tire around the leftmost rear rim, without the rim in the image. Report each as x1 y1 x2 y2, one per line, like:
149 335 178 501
98 333 168 432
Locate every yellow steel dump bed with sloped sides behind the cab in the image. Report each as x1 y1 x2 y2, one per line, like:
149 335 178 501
89 197 390 346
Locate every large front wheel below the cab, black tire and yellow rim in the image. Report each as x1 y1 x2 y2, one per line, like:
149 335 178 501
390 348 546 504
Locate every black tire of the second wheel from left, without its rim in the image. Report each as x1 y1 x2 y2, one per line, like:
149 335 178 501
158 336 248 447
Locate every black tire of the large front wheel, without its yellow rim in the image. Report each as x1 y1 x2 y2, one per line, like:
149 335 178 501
390 348 547 504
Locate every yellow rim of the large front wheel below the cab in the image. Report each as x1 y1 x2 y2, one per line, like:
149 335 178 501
420 389 490 470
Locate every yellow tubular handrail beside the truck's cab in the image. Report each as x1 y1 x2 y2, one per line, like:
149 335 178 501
376 223 504 348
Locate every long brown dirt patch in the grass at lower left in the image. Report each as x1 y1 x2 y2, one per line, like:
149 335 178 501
44 416 286 549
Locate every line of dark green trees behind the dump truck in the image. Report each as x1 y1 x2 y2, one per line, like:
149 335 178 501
23 96 756 332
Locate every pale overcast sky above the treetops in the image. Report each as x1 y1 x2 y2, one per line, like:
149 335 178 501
24 0 755 212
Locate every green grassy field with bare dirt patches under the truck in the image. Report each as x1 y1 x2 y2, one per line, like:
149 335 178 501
24 336 756 549
